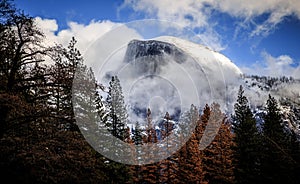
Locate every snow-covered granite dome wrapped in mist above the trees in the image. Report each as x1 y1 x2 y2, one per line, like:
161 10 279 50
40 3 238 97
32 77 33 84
106 36 242 122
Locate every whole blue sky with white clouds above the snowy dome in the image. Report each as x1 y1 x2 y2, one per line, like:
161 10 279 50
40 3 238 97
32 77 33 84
15 0 300 77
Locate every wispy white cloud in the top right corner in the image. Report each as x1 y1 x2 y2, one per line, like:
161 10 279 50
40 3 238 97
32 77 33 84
208 0 300 36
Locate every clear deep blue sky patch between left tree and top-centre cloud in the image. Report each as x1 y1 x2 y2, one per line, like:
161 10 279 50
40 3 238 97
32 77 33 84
15 0 126 29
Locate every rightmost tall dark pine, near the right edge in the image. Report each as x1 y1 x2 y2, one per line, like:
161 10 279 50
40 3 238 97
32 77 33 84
262 95 293 183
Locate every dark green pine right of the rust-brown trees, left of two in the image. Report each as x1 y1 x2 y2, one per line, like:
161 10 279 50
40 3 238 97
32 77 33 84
232 86 260 183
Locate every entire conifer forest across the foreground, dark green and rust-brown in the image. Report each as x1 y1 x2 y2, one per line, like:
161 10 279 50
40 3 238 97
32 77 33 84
0 0 300 184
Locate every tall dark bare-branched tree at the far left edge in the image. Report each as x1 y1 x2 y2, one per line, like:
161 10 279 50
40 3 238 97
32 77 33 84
0 0 50 137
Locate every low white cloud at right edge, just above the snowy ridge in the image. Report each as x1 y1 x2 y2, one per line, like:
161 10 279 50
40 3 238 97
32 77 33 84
241 52 300 79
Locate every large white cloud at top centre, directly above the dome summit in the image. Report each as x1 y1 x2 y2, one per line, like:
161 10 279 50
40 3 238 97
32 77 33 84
120 0 225 51
